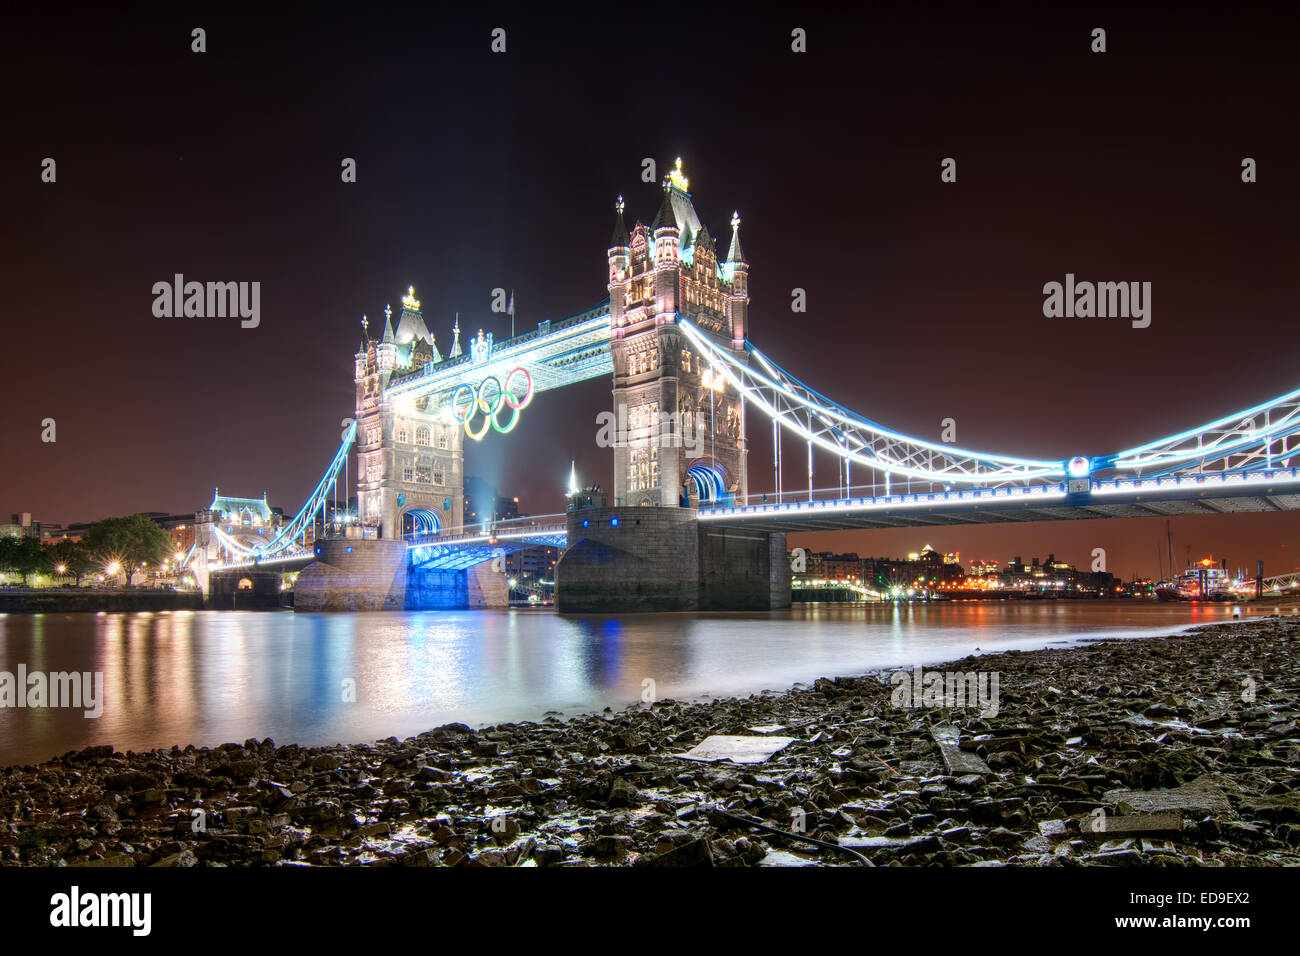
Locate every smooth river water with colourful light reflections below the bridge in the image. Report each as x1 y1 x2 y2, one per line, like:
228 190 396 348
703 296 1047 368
0 601 1253 765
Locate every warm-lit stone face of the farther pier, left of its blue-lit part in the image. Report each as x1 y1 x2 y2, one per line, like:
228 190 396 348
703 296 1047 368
294 537 408 611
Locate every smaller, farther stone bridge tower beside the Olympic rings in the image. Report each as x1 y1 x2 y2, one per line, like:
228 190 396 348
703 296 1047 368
355 289 464 538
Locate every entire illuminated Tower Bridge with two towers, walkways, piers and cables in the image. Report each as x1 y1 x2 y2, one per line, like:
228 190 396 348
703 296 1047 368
191 160 1300 610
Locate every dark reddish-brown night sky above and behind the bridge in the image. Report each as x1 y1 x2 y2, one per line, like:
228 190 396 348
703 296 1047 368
0 3 1300 576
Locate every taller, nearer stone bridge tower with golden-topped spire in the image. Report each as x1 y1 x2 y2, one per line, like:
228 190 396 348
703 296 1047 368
608 159 749 507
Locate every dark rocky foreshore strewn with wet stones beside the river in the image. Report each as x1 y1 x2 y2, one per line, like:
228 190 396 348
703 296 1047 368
0 618 1300 866
